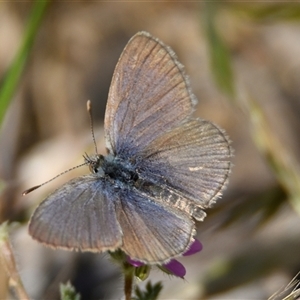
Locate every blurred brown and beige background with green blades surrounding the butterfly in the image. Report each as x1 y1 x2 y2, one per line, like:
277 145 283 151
0 1 300 299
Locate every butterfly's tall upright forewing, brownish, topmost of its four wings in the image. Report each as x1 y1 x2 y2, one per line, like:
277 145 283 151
105 32 196 159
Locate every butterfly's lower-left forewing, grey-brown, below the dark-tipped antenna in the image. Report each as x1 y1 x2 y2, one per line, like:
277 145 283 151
29 175 122 252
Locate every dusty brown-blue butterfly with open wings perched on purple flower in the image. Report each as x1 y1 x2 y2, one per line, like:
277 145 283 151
29 32 232 264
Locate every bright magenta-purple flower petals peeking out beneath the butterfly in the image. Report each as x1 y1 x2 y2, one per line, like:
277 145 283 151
127 239 203 278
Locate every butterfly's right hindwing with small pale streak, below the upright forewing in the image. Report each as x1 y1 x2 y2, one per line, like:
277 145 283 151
137 119 232 208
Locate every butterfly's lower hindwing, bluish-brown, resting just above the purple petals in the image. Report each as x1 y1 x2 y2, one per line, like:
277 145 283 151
117 190 195 263
